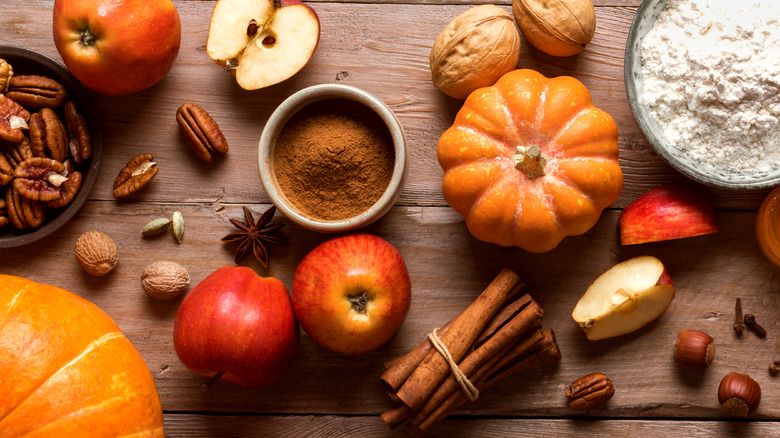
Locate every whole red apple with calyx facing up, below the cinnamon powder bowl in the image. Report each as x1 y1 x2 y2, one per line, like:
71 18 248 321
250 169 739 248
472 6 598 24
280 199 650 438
293 234 412 354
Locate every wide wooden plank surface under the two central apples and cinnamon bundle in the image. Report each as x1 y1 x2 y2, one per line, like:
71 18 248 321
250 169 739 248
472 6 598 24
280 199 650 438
0 201 780 419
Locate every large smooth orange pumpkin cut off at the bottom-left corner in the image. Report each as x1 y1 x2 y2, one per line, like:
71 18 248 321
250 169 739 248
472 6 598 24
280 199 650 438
0 275 164 438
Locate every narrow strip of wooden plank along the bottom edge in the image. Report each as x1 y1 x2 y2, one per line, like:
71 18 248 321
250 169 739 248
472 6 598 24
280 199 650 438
165 414 780 438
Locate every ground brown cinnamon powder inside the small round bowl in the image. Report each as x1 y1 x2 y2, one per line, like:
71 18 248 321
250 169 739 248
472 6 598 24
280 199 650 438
273 99 395 220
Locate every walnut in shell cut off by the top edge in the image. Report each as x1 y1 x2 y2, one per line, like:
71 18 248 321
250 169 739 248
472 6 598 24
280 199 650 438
512 0 596 56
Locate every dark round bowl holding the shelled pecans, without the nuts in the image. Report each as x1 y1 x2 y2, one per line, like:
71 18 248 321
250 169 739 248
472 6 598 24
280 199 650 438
0 46 103 248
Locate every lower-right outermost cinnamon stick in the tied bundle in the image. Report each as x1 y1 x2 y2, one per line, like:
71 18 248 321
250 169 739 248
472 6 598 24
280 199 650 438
409 329 561 436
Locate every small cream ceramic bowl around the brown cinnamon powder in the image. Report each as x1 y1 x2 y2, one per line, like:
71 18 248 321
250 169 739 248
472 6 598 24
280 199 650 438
257 84 408 233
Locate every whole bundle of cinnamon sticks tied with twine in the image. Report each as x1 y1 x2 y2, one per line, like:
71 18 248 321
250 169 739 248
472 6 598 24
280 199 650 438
380 269 561 436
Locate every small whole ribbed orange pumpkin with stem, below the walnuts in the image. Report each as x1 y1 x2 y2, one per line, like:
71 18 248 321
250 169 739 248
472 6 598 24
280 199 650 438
437 70 623 253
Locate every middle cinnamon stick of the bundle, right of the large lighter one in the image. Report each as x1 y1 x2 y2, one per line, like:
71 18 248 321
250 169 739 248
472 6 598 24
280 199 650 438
412 299 544 424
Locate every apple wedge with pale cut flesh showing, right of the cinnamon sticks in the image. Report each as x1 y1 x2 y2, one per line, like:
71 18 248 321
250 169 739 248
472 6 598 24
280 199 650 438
571 256 674 341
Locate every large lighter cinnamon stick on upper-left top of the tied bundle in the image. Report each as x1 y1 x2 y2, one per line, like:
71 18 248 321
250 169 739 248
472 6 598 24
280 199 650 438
396 268 520 412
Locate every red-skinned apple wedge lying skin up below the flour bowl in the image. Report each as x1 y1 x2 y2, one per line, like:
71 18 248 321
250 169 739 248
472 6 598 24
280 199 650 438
618 184 718 245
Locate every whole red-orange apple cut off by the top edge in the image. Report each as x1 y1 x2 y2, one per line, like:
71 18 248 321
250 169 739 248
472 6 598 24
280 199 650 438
53 0 181 96
